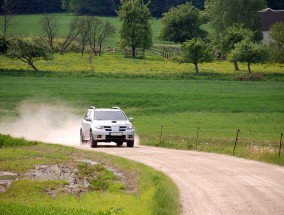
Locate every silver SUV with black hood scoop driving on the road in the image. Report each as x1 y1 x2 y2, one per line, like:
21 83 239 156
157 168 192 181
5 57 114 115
80 106 135 148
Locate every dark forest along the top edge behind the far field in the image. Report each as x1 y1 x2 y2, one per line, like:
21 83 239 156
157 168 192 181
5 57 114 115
0 0 284 17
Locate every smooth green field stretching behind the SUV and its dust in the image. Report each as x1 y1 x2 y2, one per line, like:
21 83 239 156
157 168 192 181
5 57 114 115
0 74 284 163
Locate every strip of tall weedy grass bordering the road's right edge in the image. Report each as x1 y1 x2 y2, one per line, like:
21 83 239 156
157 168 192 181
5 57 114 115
140 132 284 166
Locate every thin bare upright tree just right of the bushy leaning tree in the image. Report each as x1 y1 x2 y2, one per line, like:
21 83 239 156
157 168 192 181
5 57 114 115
40 14 59 52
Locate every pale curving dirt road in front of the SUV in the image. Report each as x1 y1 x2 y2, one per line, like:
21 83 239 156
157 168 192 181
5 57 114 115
78 145 284 215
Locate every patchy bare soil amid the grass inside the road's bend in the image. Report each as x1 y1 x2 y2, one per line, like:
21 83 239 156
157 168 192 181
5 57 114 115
0 159 137 198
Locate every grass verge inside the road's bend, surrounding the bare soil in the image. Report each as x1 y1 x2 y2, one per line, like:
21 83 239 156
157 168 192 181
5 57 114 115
0 135 179 215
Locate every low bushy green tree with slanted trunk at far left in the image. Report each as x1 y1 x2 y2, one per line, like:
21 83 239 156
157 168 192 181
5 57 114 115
8 38 53 72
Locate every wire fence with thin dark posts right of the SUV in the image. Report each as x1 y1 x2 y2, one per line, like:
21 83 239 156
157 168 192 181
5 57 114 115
137 125 283 157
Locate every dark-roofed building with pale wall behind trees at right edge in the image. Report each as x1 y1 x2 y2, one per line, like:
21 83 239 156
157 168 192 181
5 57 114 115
258 8 284 42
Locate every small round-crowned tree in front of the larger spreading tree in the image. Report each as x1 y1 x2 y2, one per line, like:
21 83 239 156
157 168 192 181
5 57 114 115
181 38 213 74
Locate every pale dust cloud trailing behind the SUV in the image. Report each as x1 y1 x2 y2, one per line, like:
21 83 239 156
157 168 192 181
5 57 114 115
0 102 81 145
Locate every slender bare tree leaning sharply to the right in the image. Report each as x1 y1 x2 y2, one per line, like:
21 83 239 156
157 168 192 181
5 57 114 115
60 17 80 55
